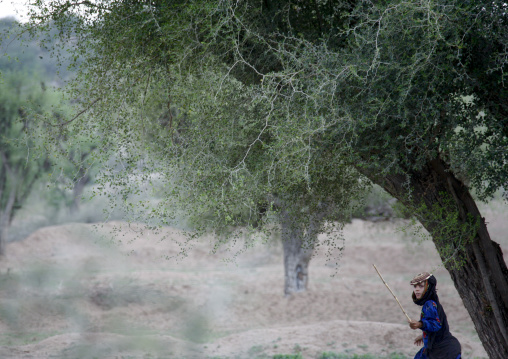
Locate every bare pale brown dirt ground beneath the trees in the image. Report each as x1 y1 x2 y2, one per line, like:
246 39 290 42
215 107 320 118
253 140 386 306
0 202 508 359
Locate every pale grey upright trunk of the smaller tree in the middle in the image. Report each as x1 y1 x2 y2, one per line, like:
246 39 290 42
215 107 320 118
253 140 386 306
280 204 326 296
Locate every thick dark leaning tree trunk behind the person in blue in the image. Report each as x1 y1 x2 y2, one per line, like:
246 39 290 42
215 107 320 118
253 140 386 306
359 159 508 359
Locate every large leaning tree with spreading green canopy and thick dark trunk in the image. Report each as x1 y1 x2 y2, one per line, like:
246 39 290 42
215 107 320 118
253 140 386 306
24 0 508 358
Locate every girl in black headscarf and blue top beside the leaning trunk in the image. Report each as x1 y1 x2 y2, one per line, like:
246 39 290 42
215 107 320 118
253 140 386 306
409 272 461 359
